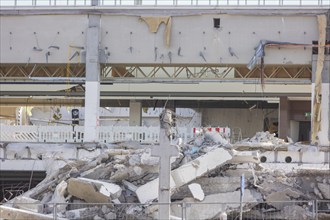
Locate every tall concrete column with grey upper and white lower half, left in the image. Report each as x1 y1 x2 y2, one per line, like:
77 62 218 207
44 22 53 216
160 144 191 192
84 15 101 142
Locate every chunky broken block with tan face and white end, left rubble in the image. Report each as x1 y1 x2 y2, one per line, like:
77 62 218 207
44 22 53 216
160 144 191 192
68 178 121 203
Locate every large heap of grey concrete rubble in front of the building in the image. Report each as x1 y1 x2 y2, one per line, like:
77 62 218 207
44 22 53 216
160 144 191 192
0 131 330 220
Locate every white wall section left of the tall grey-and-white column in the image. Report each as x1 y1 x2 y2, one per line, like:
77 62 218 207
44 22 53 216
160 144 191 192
0 15 88 63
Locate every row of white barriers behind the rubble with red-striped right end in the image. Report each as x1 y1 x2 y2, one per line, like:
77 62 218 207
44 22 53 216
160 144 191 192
0 125 218 144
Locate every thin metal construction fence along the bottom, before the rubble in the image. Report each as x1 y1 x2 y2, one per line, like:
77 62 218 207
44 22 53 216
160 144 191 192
0 200 330 220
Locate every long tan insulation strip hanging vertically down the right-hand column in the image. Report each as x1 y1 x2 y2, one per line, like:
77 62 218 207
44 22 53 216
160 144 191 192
311 15 327 143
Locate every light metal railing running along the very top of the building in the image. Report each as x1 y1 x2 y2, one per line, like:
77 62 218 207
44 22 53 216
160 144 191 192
0 0 330 7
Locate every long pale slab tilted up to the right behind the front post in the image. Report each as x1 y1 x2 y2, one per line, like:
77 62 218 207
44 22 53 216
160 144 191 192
136 148 232 203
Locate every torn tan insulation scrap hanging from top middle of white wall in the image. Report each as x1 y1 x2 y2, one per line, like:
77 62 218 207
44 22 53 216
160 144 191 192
141 16 172 47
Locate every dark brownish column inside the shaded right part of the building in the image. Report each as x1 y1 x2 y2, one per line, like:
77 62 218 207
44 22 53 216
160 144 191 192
278 96 290 139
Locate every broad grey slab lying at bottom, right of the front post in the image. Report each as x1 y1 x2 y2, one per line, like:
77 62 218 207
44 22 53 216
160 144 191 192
171 189 262 220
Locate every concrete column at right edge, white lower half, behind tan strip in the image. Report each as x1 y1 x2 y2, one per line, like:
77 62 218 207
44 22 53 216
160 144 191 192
312 55 330 146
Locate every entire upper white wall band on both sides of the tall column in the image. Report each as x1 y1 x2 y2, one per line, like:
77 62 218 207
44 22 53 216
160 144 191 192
0 14 318 64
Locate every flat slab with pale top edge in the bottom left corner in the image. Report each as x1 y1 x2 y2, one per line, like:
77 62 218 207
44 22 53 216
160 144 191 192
0 205 56 220
